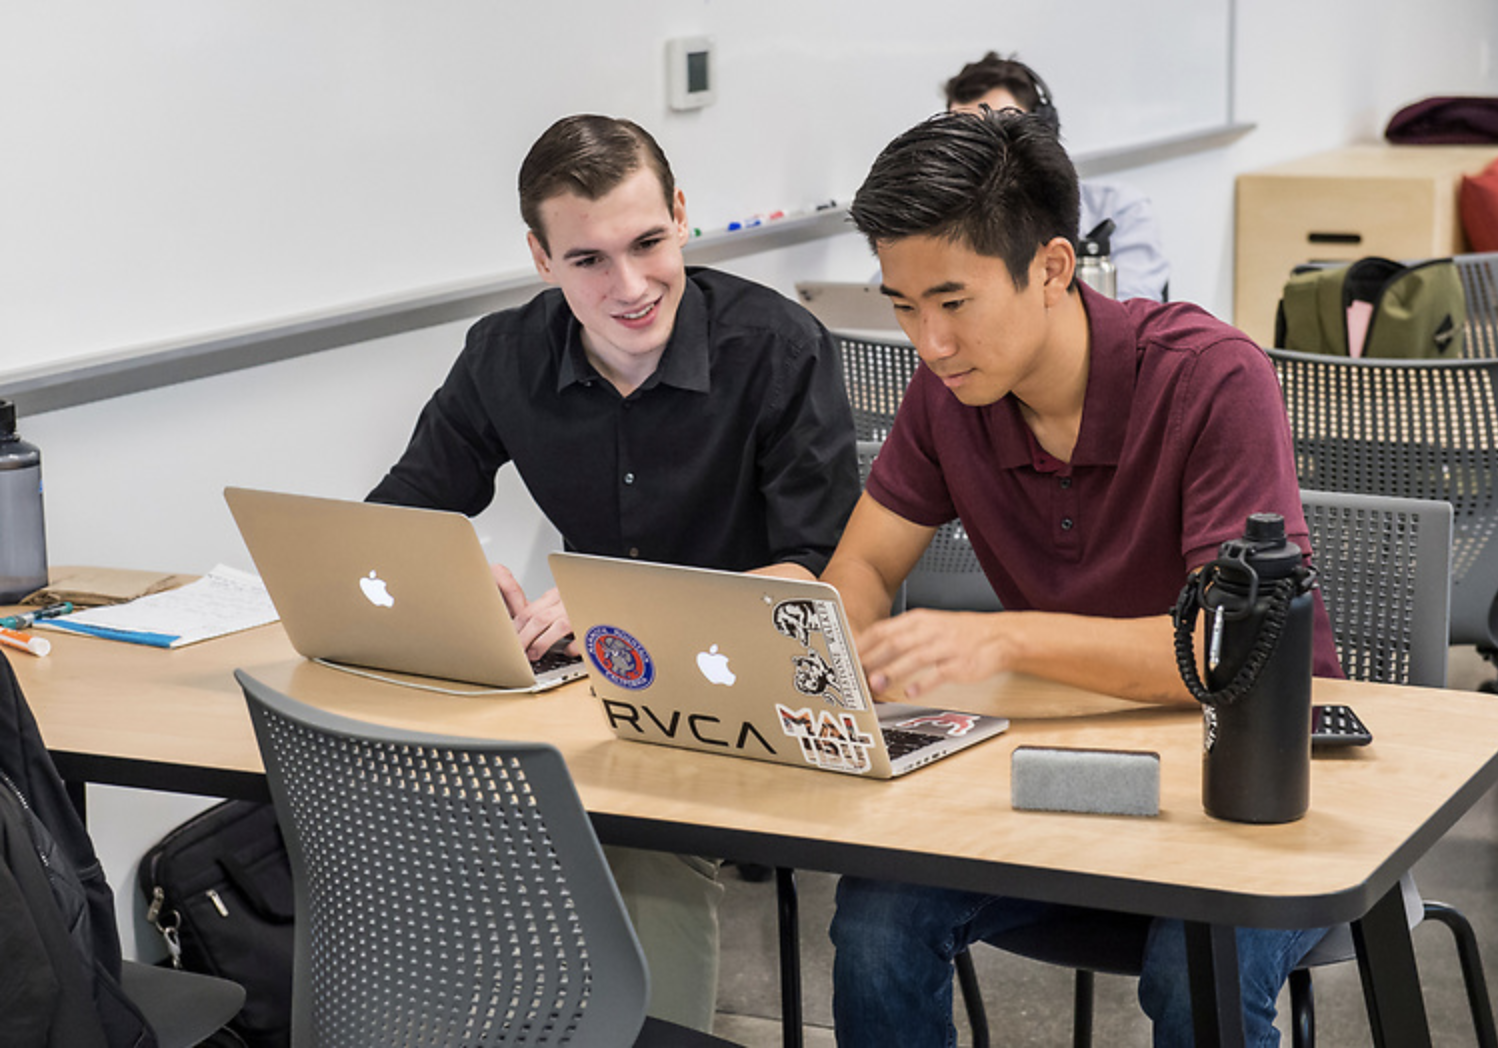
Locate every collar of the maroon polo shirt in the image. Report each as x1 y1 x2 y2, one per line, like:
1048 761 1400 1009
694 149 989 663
989 280 1135 469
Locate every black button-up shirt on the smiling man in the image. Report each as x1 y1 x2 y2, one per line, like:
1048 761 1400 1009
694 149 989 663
369 268 858 573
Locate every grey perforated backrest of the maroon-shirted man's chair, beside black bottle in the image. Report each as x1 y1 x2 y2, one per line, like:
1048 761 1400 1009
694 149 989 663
1300 491 1452 687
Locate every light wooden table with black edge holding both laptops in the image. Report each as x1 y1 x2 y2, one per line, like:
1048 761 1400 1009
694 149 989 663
12 616 1498 1048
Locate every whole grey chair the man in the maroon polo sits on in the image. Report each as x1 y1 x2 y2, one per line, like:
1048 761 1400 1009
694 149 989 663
957 491 1498 1048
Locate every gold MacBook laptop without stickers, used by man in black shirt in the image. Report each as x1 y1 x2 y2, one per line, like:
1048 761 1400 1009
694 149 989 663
223 488 586 692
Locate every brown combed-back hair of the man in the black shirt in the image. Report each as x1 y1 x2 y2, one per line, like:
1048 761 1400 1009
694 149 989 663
520 114 676 253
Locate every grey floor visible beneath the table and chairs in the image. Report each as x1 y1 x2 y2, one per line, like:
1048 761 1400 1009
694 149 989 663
715 648 1498 1048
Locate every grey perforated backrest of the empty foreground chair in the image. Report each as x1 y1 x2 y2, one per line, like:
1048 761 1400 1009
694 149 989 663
235 671 649 1048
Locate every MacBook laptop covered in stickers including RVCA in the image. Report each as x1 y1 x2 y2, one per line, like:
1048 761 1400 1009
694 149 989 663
550 552 1008 779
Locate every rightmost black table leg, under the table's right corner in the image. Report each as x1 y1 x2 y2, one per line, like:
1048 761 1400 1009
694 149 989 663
1353 885 1431 1048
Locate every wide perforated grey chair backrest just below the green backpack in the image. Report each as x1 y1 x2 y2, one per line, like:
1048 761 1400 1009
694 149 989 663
1267 349 1498 645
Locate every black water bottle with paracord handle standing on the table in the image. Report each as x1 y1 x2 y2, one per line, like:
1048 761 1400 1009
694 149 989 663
1174 514 1315 823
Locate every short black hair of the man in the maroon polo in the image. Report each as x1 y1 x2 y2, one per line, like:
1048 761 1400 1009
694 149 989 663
849 109 1080 287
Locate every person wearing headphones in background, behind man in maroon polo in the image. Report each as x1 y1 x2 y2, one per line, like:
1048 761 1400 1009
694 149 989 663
945 51 1170 302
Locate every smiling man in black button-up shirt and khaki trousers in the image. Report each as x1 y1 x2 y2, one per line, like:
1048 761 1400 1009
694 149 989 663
369 115 860 1030
